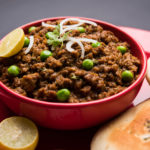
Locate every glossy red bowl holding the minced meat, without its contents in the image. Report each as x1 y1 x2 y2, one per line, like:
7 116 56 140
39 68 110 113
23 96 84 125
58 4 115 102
0 17 147 130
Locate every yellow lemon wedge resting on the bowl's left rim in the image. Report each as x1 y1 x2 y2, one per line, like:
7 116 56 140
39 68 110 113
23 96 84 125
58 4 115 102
0 28 25 57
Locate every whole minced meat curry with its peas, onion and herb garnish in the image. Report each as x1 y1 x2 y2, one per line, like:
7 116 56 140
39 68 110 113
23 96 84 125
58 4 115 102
0 18 140 103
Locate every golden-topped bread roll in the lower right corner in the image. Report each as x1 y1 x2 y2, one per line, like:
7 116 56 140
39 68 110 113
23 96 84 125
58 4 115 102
91 99 150 150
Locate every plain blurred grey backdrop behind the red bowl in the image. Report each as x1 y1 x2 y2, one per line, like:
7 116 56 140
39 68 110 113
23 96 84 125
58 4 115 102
0 0 150 38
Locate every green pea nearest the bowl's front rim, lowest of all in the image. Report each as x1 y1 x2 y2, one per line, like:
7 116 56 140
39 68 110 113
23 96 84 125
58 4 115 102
56 89 70 102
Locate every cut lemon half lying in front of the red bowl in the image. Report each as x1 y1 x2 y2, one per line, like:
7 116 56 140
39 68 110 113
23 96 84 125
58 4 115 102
0 116 39 150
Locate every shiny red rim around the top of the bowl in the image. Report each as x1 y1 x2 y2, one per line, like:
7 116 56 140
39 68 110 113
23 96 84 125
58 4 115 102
0 16 147 108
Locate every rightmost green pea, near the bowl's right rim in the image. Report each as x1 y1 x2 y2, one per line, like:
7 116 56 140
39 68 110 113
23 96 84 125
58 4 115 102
122 70 134 82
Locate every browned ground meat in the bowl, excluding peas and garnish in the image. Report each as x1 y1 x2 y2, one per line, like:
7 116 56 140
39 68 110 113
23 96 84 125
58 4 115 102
0 20 140 103
